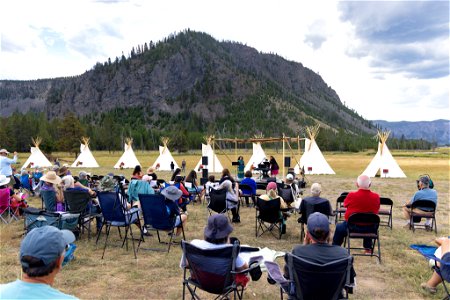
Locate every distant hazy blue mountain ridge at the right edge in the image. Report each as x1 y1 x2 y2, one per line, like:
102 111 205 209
372 119 450 146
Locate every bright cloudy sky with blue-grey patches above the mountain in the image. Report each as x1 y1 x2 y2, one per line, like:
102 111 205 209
0 0 450 121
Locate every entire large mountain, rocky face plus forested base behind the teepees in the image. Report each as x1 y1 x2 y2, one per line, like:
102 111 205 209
0 30 434 151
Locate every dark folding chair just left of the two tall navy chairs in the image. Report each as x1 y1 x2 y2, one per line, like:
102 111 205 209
64 190 102 239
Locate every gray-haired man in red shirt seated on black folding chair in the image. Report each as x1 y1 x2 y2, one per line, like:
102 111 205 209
333 174 380 253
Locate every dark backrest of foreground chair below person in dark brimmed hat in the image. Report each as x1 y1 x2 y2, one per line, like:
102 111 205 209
181 240 239 294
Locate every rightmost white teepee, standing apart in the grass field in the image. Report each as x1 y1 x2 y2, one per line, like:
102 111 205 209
363 131 406 178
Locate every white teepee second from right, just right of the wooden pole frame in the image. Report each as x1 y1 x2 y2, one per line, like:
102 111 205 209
294 125 336 175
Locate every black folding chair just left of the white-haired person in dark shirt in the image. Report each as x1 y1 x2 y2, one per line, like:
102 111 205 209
255 197 283 239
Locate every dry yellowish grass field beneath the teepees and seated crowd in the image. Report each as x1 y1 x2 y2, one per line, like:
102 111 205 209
0 149 450 299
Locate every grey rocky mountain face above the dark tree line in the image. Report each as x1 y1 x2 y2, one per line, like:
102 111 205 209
0 31 373 132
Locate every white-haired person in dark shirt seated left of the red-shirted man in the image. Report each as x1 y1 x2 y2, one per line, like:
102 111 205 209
298 182 333 224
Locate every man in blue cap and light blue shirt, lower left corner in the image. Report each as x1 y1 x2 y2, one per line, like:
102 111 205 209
0 226 77 299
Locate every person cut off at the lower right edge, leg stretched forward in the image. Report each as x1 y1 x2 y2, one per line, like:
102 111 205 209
420 237 450 294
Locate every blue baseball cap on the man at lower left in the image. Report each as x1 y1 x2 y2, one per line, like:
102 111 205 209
20 226 75 267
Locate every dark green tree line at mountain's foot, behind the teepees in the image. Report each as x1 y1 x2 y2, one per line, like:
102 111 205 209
0 108 434 155
